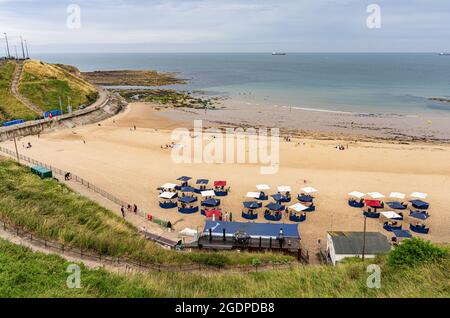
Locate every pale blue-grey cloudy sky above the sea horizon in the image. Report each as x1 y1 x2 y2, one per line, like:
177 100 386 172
0 0 450 55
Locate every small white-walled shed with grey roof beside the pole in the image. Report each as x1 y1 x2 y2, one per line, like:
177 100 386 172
327 232 391 265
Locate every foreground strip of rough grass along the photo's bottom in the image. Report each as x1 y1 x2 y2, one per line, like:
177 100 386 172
0 240 450 298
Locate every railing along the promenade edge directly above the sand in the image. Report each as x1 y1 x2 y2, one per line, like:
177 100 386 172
0 147 167 227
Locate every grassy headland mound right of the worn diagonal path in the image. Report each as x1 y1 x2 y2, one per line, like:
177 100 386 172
19 60 98 111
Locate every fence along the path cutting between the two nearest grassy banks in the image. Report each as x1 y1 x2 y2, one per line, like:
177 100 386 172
0 220 295 272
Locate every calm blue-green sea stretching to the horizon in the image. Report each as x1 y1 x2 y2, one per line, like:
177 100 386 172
35 53 450 116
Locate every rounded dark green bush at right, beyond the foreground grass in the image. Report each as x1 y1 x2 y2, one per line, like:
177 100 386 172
388 238 448 266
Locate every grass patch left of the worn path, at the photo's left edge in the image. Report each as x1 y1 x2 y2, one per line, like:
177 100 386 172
0 61 37 123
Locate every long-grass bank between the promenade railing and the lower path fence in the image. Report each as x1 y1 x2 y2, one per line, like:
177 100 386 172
0 160 292 265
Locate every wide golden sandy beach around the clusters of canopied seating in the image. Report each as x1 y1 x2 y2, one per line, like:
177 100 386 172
2 103 450 253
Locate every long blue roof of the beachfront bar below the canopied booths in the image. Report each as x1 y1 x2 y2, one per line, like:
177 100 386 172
204 221 300 238
